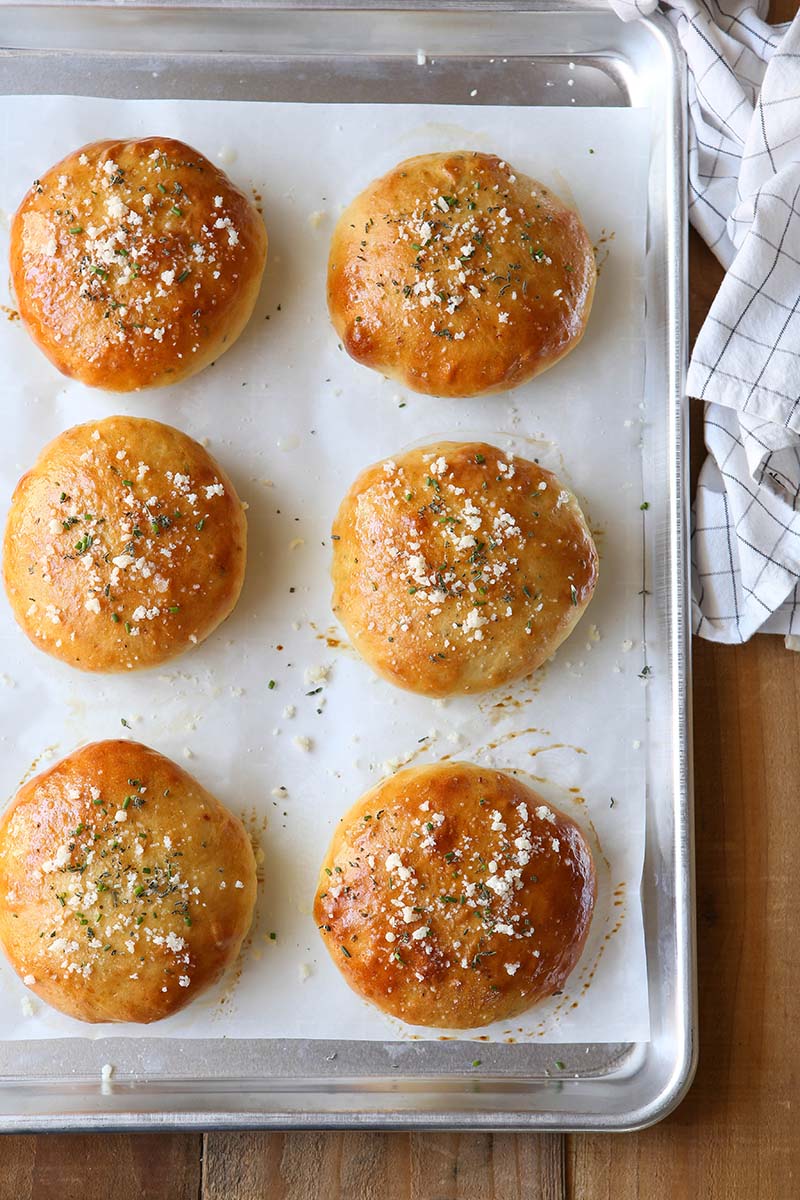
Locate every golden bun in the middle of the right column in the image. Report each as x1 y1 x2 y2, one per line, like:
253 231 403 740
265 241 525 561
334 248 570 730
332 442 597 696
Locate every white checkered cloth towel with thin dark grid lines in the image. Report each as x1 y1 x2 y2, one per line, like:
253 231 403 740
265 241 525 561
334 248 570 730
610 0 800 647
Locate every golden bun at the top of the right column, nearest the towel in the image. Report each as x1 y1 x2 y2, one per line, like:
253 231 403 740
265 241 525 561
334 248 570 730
327 150 597 396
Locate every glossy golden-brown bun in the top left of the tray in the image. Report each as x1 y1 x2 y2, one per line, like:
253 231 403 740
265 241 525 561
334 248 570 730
11 138 266 391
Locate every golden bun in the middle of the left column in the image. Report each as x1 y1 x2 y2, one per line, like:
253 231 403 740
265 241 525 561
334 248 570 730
2 416 246 671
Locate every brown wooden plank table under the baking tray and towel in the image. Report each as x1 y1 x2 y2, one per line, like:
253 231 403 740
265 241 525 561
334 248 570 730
0 0 800 1200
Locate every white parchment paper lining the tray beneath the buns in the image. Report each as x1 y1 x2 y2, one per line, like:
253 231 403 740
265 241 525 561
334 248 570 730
0 97 658 1042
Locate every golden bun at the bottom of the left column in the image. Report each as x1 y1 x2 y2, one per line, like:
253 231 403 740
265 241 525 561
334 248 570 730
0 742 255 1022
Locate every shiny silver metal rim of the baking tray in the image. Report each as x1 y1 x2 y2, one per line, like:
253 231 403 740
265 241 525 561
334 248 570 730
0 0 697 1132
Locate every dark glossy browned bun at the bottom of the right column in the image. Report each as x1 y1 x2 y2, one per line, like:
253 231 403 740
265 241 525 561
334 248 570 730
314 762 596 1028
